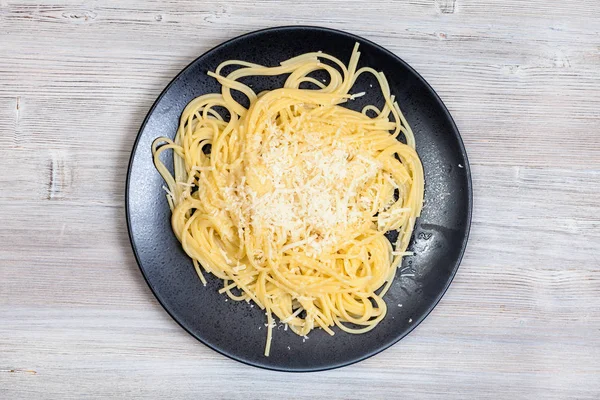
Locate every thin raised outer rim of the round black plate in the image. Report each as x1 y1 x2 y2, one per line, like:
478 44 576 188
125 25 473 372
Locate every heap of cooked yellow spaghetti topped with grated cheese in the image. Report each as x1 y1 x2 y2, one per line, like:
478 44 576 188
152 44 424 356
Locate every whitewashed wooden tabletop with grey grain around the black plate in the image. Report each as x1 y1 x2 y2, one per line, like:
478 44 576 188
0 0 600 400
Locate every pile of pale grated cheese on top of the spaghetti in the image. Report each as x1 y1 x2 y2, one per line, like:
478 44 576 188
225 109 382 256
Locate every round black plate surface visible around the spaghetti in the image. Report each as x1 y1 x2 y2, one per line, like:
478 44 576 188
126 27 472 371
